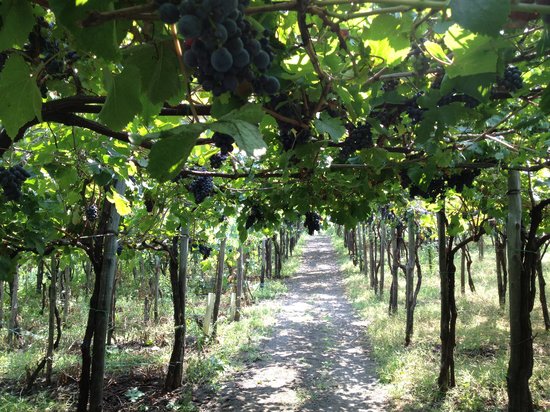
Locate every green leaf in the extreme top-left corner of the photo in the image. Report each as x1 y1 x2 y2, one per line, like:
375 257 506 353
0 0 34 50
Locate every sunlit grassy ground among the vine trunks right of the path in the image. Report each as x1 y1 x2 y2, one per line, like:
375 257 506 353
333 233 550 411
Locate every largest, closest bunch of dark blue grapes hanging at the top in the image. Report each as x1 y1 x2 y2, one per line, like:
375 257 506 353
159 0 280 96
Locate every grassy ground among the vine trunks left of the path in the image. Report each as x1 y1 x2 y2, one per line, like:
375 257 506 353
0 239 303 412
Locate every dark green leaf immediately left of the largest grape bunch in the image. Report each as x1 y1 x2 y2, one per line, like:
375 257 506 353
125 42 182 103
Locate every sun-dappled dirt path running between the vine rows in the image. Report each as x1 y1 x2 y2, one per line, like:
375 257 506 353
197 236 386 411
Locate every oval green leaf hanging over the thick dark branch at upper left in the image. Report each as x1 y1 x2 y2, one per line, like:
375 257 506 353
99 66 142 130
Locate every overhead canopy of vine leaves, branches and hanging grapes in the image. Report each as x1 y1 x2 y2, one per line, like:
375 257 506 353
0 0 550 236
